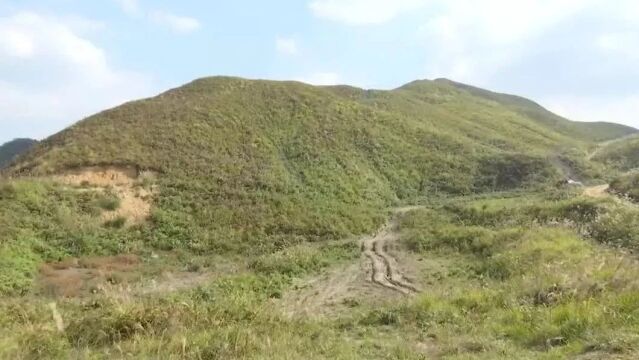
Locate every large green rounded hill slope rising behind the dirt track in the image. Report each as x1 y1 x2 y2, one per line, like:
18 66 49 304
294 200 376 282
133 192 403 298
3 77 608 252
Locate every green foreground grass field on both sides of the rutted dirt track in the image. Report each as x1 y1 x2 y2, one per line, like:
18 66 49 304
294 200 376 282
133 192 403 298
0 184 639 359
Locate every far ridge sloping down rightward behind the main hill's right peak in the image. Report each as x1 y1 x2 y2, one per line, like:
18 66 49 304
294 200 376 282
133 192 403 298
436 79 638 142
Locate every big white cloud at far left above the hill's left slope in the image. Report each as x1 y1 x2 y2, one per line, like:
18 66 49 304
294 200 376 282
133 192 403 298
0 12 152 142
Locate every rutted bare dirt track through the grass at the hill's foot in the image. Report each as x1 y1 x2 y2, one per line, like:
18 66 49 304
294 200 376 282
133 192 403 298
283 207 419 316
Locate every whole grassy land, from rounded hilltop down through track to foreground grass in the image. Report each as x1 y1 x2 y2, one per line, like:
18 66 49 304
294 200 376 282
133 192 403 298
0 77 639 360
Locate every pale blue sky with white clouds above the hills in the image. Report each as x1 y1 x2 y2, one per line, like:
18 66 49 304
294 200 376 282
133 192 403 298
0 0 639 143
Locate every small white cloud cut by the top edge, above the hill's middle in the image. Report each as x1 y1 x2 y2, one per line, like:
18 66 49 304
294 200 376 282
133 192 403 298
309 0 426 25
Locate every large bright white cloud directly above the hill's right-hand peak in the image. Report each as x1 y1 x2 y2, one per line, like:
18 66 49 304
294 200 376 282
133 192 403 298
420 0 592 83
